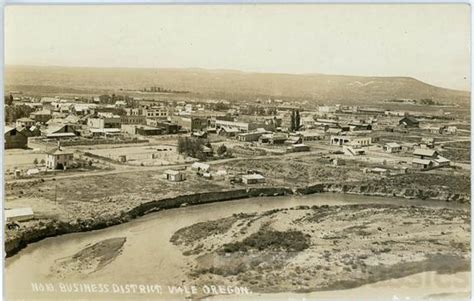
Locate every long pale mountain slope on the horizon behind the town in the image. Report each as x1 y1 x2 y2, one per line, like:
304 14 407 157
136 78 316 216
5 66 470 104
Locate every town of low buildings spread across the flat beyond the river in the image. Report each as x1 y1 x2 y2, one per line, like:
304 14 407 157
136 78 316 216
4 87 470 228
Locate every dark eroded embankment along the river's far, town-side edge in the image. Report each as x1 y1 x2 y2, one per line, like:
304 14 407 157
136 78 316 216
5 183 470 257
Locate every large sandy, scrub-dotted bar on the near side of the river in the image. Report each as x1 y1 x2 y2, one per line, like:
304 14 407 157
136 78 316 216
171 205 470 293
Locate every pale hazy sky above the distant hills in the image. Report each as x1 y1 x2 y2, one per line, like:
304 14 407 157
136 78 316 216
5 4 470 90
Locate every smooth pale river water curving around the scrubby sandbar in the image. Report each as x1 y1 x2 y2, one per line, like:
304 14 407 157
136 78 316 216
5 194 470 300
